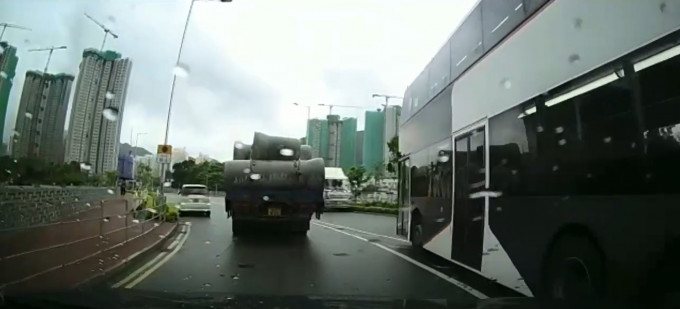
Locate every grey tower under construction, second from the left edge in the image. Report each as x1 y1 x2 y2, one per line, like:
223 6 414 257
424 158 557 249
12 71 74 163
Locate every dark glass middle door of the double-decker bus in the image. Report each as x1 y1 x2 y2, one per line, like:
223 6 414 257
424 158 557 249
451 126 486 270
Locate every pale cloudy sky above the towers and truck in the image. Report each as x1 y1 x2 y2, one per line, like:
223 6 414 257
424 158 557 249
0 0 476 161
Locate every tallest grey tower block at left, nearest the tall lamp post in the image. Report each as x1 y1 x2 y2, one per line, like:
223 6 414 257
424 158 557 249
65 49 132 174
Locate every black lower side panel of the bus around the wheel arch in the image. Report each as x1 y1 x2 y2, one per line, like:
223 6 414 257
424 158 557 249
489 196 680 295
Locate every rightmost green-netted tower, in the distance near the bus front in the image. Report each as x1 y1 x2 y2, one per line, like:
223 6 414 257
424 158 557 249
363 110 385 171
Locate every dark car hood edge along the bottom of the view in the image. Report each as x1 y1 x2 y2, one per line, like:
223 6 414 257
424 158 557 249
0 289 533 309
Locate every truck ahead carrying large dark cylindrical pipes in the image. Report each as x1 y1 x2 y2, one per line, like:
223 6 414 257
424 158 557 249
224 132 325 236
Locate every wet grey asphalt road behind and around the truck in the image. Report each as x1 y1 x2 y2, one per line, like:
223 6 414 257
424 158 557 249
101 195 512 303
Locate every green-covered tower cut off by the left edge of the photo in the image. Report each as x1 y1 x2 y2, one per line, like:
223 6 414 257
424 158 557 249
0 42 19 143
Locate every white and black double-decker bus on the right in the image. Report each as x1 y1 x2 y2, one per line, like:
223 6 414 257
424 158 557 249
397 0 680 300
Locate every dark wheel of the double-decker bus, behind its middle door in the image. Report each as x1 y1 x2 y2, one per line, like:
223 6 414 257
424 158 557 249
542 235 604 308
